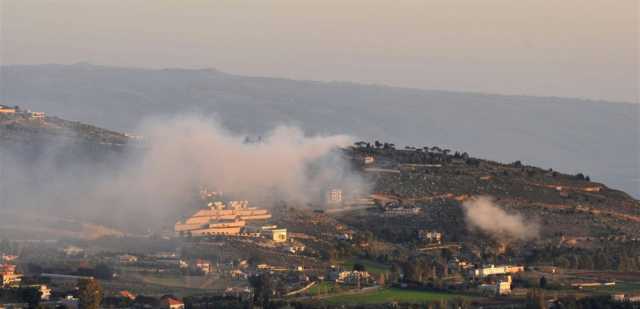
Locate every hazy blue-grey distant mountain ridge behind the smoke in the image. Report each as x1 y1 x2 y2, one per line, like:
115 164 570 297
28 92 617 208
0 64 640 197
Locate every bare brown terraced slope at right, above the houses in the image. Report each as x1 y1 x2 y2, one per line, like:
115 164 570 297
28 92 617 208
344 147 640 241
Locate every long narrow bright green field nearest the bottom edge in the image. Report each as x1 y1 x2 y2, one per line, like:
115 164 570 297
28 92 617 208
324 288 469 305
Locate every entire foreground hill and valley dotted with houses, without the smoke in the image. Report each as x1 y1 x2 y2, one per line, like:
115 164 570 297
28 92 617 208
0 106 640 309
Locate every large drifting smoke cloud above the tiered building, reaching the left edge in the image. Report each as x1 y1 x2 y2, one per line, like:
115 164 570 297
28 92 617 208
0 116 367 229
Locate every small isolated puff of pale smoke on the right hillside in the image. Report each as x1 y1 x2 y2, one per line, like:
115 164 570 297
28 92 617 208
462 196 539 240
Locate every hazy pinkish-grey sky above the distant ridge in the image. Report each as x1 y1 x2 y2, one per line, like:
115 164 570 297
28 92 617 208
0 0 640 102
